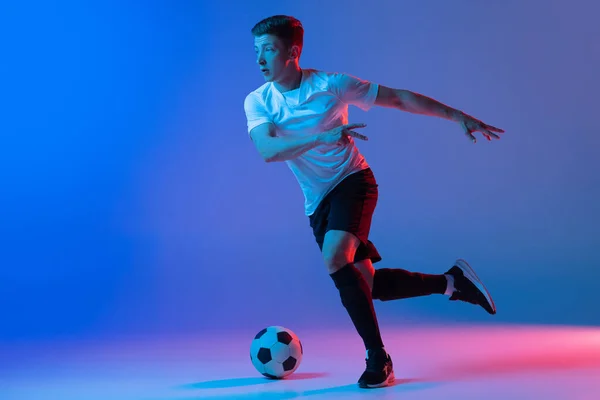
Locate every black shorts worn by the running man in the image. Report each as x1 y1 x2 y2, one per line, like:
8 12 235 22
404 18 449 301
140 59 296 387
309 168 381 263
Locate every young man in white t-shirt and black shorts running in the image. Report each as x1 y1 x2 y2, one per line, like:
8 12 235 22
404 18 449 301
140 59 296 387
244 15 504 388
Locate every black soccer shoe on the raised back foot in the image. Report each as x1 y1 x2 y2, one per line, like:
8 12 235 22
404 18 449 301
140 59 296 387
446 258 496 315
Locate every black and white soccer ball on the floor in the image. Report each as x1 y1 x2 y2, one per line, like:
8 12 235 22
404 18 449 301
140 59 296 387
250 326 303 379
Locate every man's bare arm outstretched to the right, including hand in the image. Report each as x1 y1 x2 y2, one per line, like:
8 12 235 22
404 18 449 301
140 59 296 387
375 85 504 143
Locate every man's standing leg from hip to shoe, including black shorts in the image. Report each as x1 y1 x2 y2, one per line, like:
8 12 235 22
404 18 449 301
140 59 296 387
309 169 394 387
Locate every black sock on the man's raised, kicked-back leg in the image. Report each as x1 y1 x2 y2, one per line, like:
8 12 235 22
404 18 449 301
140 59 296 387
372 268 448 301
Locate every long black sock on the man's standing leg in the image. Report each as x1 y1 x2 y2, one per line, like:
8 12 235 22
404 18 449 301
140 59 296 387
330 263 383 350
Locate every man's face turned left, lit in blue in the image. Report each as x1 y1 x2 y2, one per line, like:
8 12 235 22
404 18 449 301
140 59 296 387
254 35 291 82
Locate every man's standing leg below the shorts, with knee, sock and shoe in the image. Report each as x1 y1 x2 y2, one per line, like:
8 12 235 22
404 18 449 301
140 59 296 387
322 230 394 387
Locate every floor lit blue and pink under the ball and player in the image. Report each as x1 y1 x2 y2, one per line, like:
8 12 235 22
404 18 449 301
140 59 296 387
0 325 600 400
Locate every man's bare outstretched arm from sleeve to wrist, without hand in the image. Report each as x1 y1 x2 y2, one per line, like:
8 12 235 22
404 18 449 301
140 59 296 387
375 85 466 122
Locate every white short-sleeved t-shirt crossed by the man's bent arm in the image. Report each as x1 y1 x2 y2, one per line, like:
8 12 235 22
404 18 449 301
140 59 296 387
244 69 378 215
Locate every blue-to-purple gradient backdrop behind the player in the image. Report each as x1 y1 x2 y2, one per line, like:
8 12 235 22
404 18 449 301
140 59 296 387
0 0 600 342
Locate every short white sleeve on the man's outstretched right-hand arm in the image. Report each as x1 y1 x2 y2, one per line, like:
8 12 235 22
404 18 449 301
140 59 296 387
329 73 379 111
